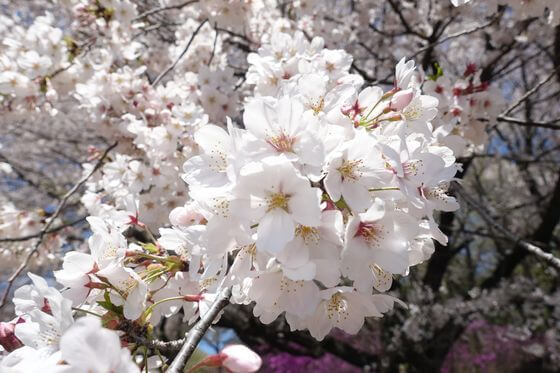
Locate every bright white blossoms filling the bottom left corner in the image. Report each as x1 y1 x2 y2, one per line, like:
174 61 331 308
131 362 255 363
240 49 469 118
0 273 140 373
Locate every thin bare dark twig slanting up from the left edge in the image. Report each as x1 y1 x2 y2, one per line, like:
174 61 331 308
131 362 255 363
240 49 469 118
0 142 118 308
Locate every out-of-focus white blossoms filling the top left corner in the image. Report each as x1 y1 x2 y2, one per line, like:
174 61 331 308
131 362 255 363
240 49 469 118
0 0 141 118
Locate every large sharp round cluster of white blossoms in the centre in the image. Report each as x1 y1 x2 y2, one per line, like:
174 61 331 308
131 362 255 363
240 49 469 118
178 34 459 339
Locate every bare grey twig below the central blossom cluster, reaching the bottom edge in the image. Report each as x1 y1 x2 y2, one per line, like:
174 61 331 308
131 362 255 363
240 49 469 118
166 287 231 373
